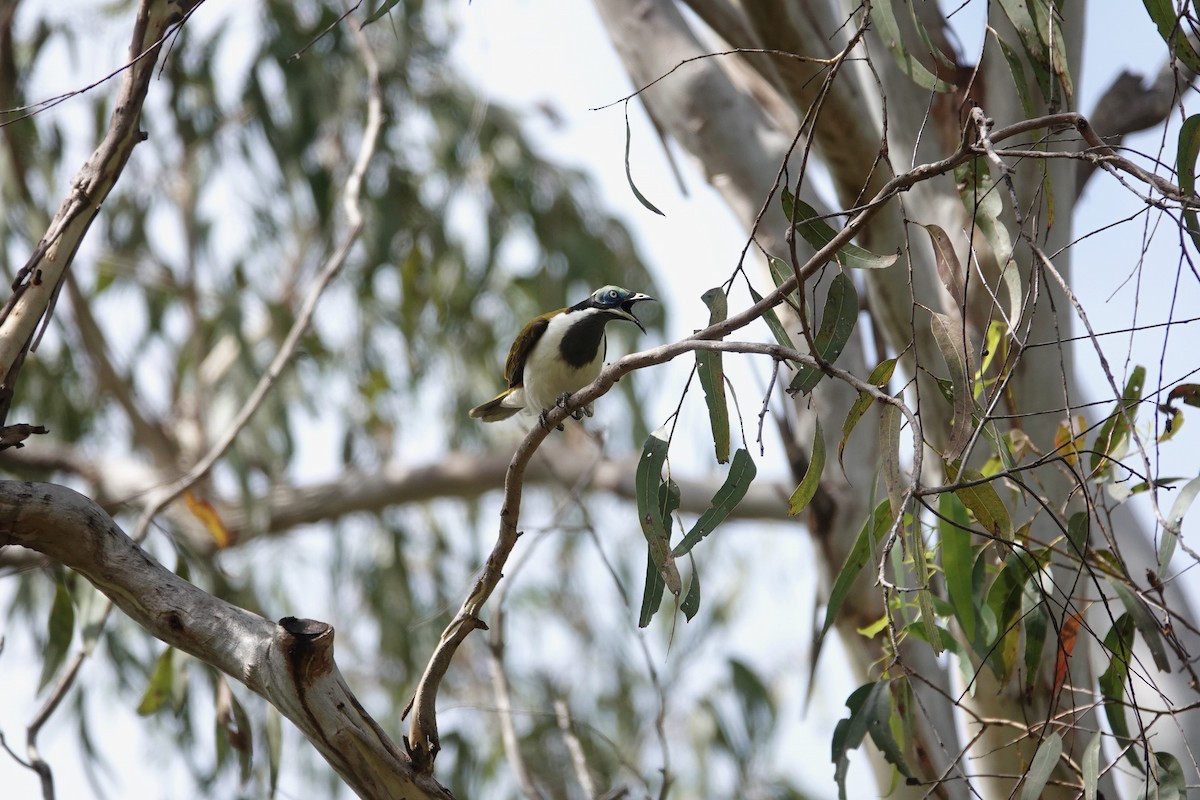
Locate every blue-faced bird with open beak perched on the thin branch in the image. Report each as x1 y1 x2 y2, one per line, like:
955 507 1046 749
469 285 654 427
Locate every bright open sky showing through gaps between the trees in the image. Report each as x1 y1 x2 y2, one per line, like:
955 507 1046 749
0 0 1200 798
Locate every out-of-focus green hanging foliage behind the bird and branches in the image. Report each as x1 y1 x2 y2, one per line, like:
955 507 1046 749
0 0 799 798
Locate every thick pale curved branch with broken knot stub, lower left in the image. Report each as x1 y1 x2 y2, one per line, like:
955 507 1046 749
0 481 452 800
